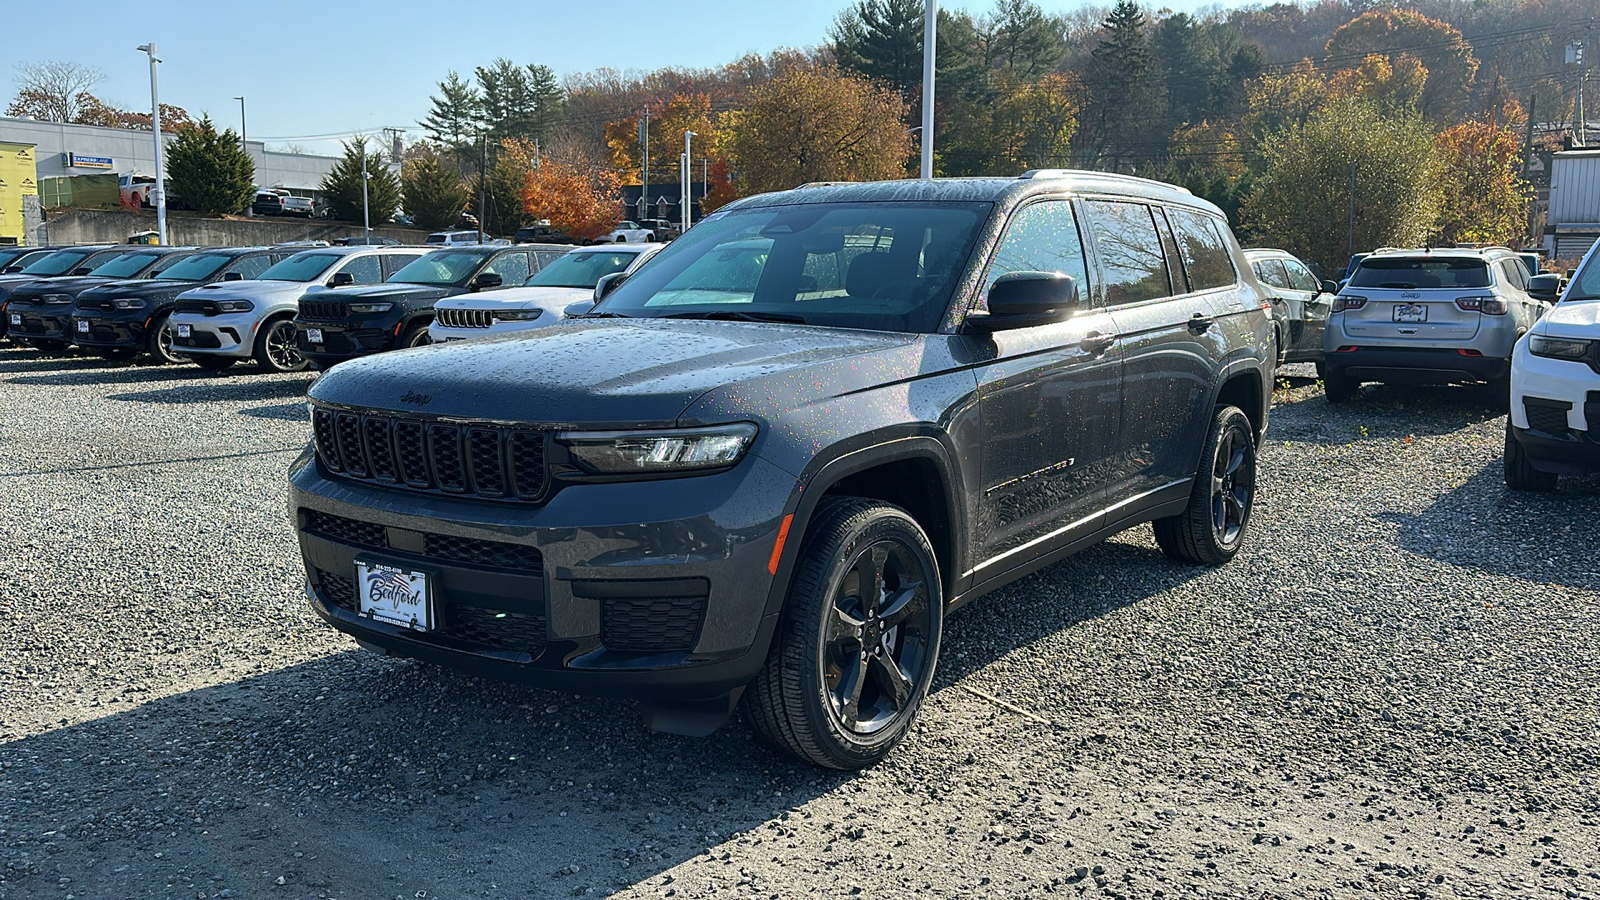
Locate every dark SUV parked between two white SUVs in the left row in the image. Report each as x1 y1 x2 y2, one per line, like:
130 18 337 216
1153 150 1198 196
294 243 571 368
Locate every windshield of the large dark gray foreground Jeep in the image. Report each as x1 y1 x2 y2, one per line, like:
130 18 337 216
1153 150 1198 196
595 202 990 333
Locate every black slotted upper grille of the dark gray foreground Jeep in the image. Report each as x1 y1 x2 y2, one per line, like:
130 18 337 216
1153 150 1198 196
312 408 547 500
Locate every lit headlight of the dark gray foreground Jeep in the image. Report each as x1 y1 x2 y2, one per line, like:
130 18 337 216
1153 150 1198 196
557 421 757 476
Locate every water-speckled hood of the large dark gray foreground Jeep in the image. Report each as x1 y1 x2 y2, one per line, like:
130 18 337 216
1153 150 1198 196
310 319 930 428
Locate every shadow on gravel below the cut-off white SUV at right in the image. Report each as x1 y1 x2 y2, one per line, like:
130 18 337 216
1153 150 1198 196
1379 460 1600 591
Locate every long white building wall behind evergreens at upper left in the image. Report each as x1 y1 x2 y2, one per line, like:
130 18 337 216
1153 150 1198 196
0 117 338 194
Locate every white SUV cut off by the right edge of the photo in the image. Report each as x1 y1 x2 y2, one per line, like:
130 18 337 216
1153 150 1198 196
1506 245 1600 490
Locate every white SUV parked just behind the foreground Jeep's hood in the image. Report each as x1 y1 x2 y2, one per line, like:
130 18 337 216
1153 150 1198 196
427 243 666 343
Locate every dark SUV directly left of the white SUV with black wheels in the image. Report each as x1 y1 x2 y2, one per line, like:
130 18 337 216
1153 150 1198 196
72 247 293 364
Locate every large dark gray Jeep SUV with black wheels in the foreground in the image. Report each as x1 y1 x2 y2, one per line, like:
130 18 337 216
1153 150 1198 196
290 171 1274 769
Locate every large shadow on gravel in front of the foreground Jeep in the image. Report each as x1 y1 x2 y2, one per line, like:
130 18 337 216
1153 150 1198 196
0 652 853 897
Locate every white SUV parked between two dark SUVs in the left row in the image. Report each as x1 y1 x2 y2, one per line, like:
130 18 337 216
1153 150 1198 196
166 247 427 372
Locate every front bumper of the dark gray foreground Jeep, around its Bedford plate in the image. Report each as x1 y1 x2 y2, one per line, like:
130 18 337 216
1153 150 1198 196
290 452 795 703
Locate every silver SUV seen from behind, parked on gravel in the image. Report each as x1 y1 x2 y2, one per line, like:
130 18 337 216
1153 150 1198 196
1318 247 1550 404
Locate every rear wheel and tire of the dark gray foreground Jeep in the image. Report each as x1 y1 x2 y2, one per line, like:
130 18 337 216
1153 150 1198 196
1155 407 1256 565
